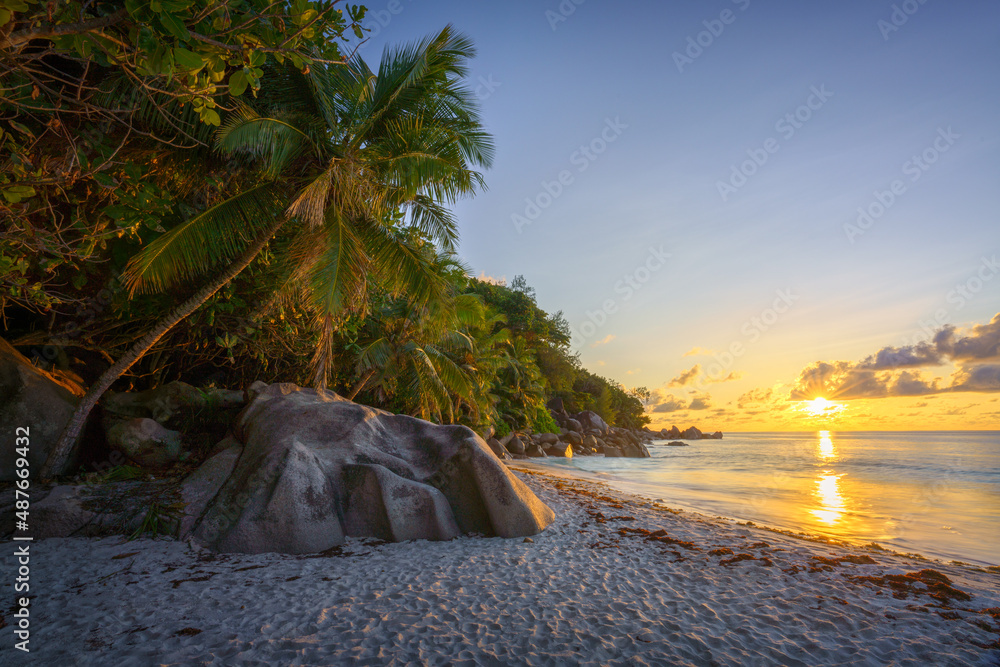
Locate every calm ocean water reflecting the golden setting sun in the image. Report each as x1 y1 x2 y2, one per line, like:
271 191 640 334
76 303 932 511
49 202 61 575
532 431 1000 565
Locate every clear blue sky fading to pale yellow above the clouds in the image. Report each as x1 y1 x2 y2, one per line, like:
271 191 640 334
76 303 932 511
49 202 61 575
352 0 1000 423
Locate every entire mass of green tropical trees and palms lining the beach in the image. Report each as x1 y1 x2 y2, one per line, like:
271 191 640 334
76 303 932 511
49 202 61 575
0 0 648 478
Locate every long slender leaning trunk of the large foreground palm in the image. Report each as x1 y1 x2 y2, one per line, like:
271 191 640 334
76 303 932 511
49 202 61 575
39 218 286 480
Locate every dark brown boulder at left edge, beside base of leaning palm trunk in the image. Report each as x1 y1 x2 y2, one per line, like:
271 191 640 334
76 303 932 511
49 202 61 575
0 338 79 482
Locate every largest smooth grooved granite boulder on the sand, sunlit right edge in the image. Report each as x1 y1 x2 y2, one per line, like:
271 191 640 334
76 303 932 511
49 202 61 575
191 384 555 554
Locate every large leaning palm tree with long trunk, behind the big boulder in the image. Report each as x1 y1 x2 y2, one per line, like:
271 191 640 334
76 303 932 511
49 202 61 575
41 26 493 478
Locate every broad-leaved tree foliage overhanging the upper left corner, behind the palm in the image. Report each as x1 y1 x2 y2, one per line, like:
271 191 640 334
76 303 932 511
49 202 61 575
0 0 365 314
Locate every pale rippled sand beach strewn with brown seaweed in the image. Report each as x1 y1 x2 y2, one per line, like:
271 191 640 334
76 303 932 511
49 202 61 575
0 465 1000 666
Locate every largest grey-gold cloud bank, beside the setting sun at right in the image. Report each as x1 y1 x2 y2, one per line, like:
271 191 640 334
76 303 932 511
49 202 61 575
790 313 1000 400
